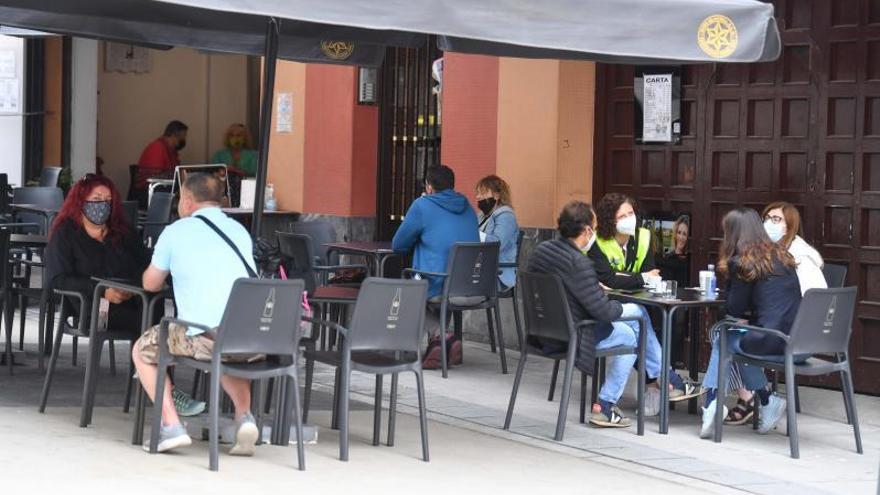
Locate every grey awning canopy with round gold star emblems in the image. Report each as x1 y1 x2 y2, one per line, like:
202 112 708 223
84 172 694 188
0 0 780 65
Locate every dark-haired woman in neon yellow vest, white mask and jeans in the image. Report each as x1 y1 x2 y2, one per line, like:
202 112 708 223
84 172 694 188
587 193 702 416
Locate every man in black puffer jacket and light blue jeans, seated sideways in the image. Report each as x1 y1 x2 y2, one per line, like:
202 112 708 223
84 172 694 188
529 201 639 427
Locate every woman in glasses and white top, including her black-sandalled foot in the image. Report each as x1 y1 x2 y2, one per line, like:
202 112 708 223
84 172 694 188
724 201 828 425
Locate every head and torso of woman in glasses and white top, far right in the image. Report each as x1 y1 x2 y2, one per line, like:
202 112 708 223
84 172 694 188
764 201 828 295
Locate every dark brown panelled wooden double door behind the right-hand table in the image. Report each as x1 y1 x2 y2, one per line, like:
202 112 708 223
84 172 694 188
594 0 880 394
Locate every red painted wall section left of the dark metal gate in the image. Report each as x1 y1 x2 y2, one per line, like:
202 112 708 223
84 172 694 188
303 64 379 216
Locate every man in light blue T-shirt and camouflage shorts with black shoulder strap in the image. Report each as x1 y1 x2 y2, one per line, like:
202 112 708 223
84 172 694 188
132 173 259 455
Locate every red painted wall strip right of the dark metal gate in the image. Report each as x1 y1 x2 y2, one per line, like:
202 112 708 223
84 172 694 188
440 53 498 205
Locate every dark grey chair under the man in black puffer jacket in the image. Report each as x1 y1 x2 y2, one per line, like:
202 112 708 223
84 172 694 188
504 272 647 442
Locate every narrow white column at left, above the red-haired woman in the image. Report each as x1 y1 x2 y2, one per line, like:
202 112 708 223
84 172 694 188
70 38 98 180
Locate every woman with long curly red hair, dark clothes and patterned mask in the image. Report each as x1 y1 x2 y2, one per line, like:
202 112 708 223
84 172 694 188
45 174 149 328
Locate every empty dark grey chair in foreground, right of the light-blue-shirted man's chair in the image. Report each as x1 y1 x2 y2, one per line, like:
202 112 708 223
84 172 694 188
304 278 429 462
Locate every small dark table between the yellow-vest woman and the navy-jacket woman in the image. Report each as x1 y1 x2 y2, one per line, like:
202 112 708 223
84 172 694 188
608 288 725 434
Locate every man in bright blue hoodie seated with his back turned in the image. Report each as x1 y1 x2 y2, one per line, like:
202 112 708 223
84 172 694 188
391 165 480 369
